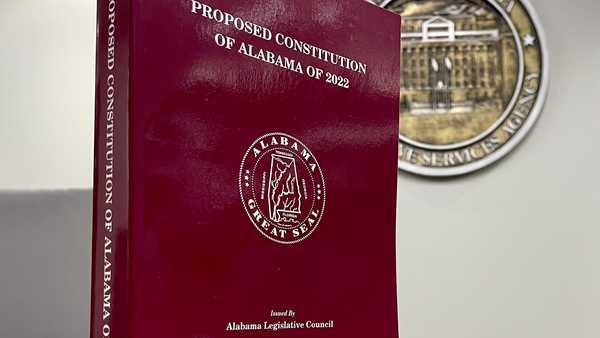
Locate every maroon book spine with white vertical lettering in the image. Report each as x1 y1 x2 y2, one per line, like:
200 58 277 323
90 0 131 338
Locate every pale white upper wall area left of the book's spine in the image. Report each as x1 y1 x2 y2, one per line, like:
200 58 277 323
0 0 96 190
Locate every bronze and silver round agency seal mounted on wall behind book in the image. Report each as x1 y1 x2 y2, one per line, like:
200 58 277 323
376 0 548 176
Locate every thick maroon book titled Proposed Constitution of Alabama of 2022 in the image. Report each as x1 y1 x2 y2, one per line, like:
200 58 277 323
91 0 400 338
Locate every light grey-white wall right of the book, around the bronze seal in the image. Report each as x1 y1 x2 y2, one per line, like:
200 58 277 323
398 0 600 338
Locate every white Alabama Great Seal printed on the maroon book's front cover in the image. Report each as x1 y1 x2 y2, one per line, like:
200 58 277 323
239 133 326 244
